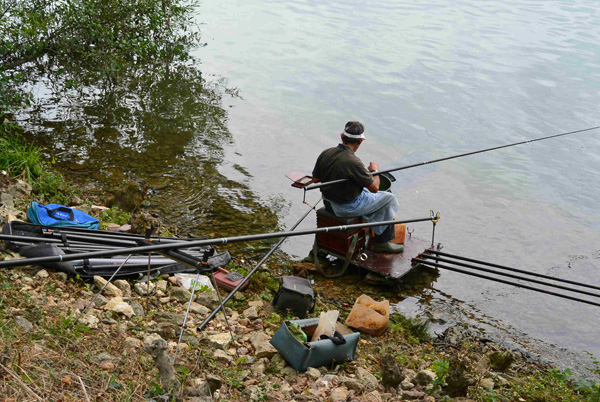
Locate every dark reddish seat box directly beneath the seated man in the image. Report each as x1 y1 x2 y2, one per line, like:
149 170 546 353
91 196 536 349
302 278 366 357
316 208 366 256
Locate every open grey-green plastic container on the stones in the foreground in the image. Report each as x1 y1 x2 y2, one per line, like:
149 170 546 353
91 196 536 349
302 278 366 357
271 318 360 371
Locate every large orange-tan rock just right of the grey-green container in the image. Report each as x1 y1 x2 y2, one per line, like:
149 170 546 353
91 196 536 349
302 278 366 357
346 295 390 336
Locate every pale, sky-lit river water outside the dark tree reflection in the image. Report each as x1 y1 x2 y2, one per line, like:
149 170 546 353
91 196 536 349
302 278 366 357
197 0 600 362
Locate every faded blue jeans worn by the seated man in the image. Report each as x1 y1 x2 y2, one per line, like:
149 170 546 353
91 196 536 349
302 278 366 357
328 188 400 239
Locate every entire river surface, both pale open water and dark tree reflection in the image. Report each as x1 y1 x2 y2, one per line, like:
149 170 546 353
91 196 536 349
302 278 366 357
17 0 600 365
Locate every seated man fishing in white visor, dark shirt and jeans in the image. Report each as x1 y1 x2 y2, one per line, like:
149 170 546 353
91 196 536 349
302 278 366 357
312 121 404 253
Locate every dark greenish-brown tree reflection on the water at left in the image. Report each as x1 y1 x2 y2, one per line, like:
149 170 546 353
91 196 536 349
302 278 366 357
17 60 282 250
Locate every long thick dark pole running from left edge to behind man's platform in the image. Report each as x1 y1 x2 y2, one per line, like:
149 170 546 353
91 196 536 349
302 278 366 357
0 216 437 268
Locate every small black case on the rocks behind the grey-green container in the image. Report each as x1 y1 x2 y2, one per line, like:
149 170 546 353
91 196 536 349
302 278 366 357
273 276 315 318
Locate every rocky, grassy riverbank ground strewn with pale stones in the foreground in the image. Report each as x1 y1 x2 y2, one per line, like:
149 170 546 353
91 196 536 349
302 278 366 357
0 179 600 402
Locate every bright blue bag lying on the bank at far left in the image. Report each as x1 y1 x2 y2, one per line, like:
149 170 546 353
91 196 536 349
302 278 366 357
27 202 100 229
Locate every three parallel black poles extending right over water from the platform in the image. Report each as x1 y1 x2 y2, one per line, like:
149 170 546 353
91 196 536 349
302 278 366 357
412 250 600 306
